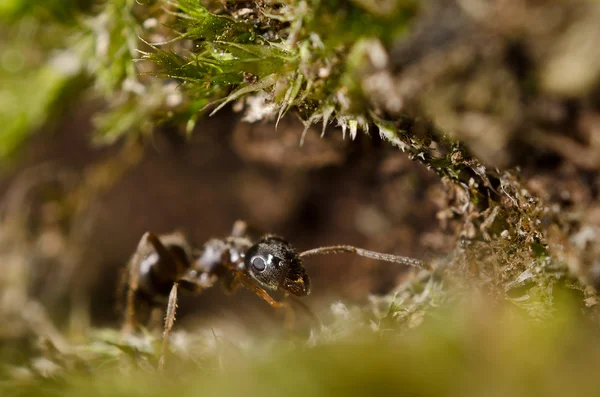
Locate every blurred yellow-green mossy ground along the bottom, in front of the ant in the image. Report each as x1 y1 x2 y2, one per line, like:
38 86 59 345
0 299 600 396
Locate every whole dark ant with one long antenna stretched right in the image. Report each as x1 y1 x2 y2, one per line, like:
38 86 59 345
123 221 429 370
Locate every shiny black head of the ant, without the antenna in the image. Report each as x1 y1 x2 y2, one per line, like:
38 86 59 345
245 235 310 296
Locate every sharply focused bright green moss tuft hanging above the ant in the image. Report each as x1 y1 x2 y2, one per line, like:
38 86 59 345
144 0 417 142
